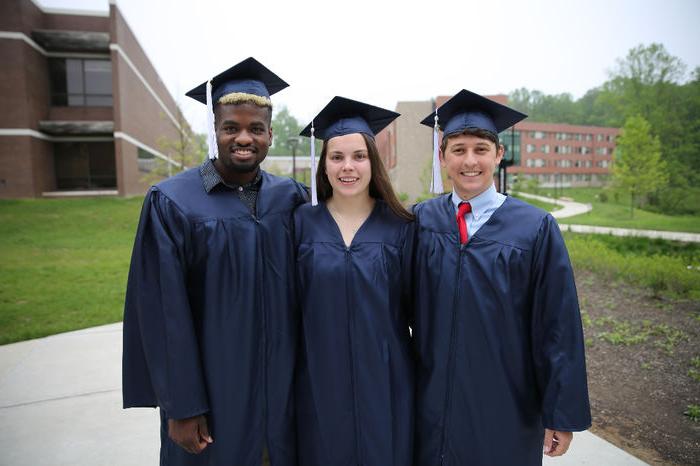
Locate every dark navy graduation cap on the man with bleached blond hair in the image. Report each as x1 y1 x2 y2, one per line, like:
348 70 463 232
185 57 289 105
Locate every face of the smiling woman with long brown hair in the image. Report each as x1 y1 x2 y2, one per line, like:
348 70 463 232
326 133 372 197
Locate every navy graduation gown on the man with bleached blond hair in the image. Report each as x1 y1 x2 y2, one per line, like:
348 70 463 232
123 169 305 466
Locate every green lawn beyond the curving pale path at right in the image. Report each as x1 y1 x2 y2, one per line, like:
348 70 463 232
528 188 700 233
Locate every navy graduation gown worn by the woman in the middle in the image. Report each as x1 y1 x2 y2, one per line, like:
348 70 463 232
295 201 414 466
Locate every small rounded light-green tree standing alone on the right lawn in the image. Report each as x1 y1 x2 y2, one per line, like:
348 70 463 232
612 116 668 216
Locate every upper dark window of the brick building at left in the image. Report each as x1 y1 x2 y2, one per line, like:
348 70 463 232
49 58 112 107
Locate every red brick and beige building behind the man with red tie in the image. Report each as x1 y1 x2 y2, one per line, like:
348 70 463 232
384 95 619 199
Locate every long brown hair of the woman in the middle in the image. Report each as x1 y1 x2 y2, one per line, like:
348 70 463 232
316 133 414 221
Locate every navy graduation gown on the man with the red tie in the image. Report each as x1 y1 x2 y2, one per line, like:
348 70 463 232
413 195 591 466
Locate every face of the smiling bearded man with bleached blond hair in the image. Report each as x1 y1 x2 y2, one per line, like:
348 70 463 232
214 103 272 184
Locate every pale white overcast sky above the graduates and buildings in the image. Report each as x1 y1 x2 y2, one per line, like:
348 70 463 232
36 0 700 132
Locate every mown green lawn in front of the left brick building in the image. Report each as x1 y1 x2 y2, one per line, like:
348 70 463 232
0 198 143 344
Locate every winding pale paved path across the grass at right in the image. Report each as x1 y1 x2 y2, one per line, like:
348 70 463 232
517 192 700 243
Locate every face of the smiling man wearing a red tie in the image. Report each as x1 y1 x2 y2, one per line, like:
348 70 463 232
440 134 503 201
